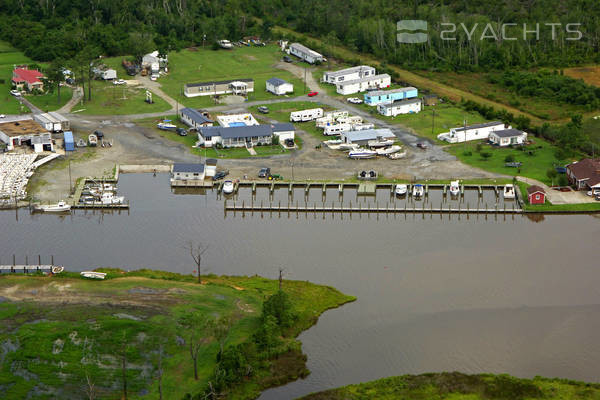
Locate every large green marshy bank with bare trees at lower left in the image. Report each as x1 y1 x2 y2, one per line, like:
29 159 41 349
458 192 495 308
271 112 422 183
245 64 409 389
0 270 354 400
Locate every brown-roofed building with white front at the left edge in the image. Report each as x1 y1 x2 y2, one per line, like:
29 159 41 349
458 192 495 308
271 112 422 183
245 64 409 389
0 119 54 153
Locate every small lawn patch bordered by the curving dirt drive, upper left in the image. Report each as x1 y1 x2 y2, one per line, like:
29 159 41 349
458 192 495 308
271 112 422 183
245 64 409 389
73 81 171 115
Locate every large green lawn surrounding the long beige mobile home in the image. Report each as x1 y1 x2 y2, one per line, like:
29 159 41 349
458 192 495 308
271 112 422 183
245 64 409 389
159 45 304 108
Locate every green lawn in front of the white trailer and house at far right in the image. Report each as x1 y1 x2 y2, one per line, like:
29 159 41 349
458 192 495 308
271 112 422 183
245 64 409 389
448 138 567 185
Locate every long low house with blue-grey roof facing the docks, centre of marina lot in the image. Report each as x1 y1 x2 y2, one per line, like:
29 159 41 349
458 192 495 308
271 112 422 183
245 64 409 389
198 125 273 147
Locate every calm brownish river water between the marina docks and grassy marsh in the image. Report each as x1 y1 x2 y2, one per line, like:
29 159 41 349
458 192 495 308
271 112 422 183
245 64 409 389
0 174 600 399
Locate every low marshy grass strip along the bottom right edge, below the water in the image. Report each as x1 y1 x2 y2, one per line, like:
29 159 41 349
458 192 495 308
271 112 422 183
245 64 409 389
302 372 600 400
